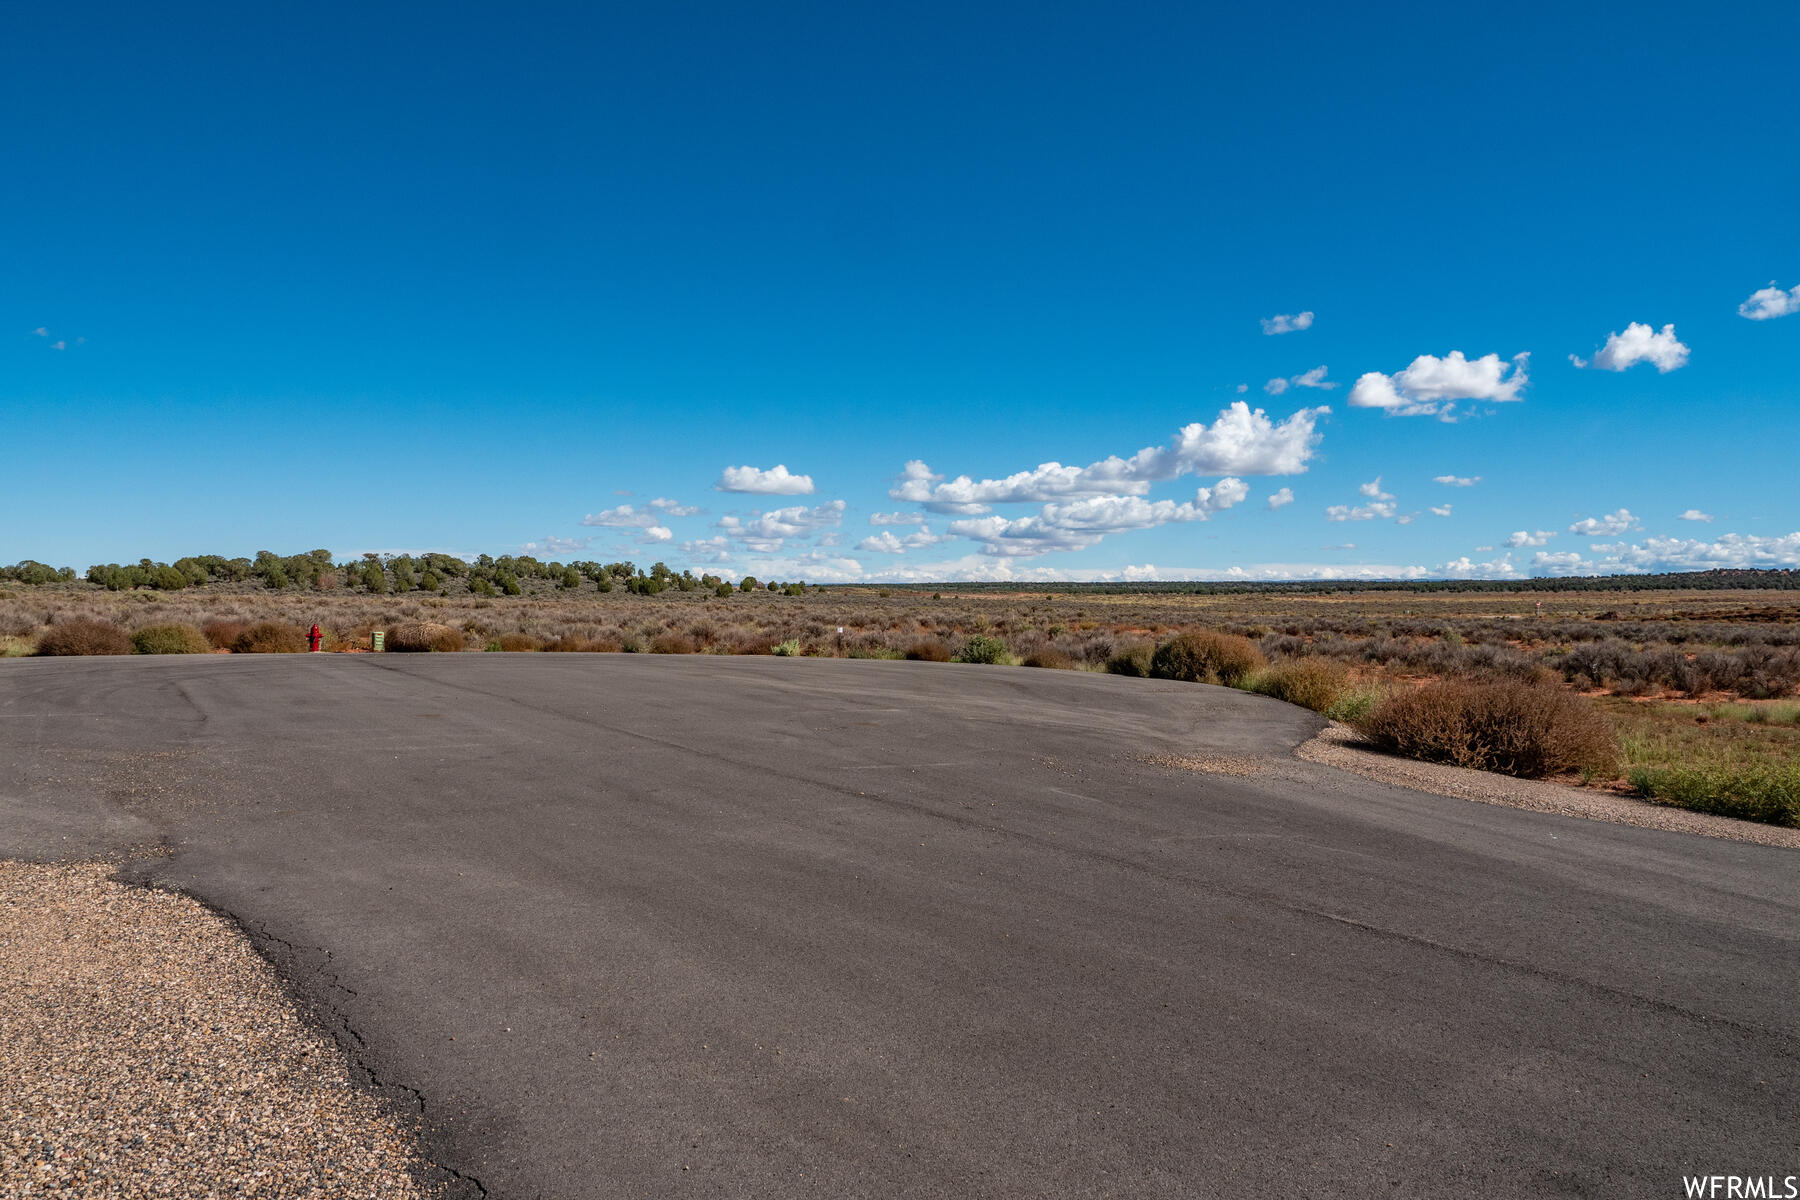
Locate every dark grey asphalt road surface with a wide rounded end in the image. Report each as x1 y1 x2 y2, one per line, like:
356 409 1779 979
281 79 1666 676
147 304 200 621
0 655 1800 1196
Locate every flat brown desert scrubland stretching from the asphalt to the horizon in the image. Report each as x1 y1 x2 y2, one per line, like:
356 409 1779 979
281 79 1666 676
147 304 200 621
0 579 1800 826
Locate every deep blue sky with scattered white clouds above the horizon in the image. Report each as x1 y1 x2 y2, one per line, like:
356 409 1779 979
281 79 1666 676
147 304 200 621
0 2 1800 581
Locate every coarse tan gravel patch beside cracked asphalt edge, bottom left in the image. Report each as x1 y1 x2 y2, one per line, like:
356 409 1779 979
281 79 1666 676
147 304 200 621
0 862 434 1200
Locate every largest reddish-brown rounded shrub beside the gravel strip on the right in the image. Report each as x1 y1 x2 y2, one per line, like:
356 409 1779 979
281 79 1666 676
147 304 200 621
1357 680 1618 779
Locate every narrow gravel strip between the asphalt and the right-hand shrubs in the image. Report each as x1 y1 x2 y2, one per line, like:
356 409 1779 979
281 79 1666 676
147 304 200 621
1294 721 1800 849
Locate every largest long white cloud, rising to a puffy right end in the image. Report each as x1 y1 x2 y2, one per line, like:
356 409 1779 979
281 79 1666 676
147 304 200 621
887 399 1330 516
